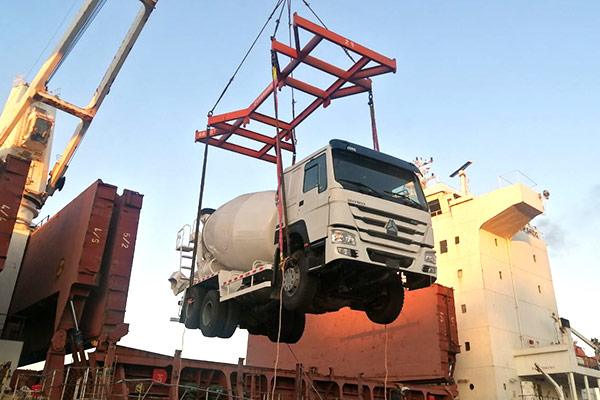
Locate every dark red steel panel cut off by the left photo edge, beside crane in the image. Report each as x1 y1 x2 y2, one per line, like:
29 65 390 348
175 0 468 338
0 155 30 271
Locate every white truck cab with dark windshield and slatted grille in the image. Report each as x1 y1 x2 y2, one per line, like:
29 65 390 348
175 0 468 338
283 140 437 323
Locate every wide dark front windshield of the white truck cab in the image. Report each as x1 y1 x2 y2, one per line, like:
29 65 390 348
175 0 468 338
333 149 427 210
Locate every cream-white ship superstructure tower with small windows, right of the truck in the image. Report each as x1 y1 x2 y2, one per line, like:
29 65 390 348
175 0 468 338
426 171 600 400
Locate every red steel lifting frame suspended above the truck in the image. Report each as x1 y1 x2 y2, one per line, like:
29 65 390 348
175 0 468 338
196 13 396 163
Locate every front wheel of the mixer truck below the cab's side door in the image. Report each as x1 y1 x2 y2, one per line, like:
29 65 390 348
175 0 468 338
281 250 317 311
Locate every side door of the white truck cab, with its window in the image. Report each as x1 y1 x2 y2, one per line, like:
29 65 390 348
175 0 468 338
298 153 329 242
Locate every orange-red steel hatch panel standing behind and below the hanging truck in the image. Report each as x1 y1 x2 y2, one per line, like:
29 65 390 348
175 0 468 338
247 284 459 383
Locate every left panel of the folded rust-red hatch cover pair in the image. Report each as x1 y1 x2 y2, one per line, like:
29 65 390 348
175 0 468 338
10 181 117 314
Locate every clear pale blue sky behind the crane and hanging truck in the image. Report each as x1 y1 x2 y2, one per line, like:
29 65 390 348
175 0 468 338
0 0 600 361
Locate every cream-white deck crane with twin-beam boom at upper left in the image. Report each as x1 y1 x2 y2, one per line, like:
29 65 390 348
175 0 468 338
0 0 158 342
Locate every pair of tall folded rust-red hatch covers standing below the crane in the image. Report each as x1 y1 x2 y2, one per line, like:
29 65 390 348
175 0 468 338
4 180 143 376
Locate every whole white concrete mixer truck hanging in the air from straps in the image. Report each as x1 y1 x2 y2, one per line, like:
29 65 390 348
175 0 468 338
170 140 437 343
